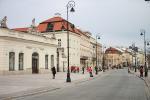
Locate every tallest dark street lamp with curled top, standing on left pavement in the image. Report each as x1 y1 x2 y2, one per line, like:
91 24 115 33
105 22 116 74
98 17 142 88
66 1 75 82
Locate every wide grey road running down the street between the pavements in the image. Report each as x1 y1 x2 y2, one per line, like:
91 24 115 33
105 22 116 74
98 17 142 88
14 69 148 100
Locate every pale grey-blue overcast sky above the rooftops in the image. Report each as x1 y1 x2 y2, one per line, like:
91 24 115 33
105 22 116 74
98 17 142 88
0 0 150 47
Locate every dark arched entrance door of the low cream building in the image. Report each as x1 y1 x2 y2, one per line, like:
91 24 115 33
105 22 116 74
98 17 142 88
32 53 39 73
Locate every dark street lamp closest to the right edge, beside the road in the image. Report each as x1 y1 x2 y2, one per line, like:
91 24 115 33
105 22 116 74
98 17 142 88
140 30 149 77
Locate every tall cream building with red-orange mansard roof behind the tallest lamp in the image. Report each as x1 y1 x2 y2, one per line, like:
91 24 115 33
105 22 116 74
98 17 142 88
38 16 102 71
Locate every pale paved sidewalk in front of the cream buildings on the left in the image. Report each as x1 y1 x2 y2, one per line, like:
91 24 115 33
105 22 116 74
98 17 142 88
0 72 103 100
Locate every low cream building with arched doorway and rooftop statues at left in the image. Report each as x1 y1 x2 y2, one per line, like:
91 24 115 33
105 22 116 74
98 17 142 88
0 28 57 75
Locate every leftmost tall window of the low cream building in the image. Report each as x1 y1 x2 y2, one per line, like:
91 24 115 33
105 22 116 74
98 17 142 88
9 52 15 71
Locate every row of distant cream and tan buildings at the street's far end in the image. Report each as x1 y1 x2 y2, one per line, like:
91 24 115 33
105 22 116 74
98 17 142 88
105 47 144 67
